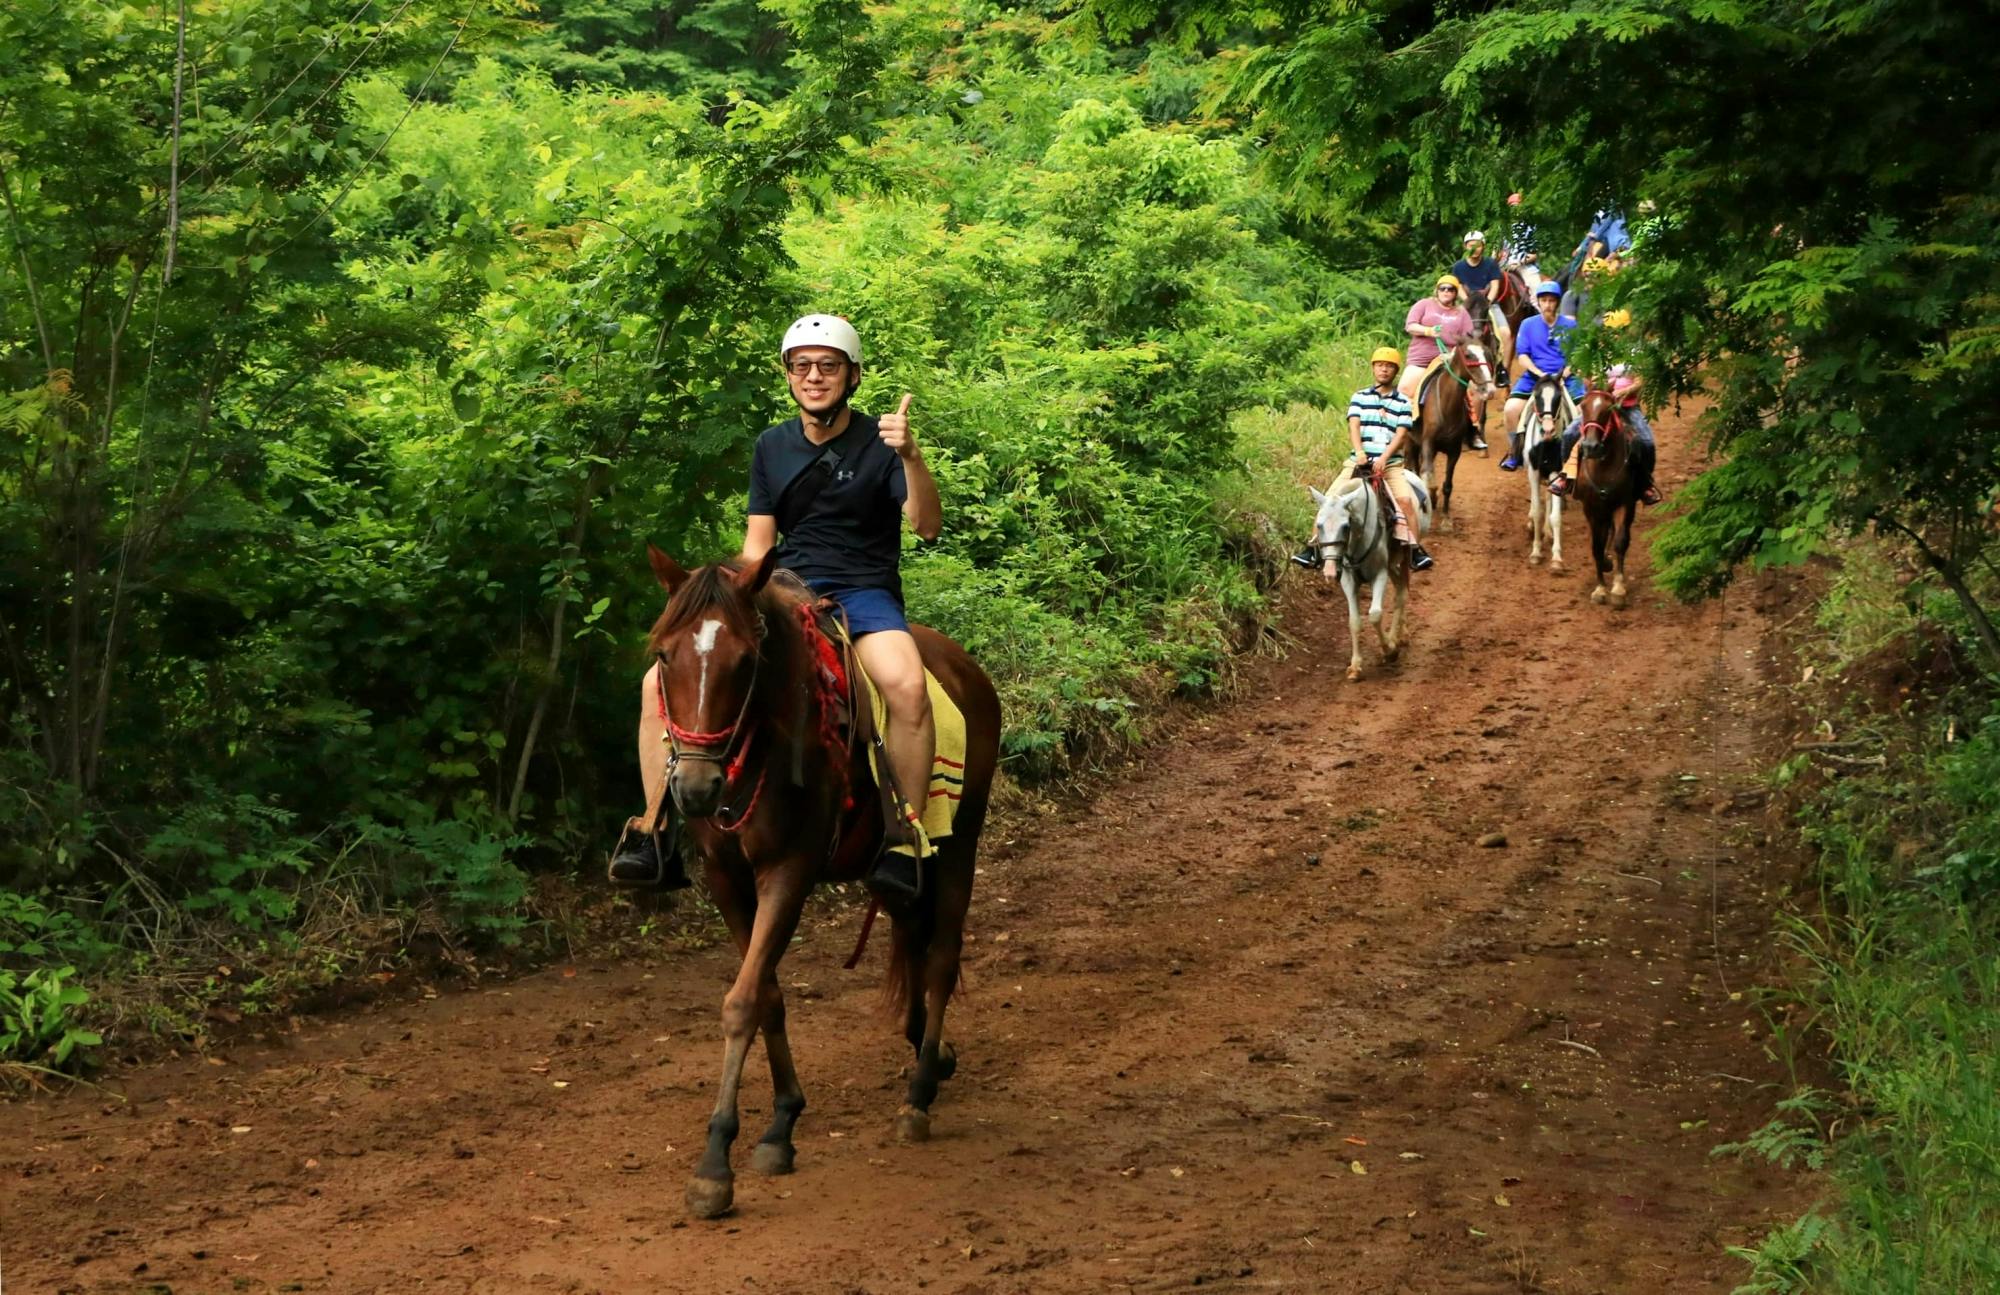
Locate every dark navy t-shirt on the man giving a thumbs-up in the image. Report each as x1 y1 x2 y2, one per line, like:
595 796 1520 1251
750 410 910 602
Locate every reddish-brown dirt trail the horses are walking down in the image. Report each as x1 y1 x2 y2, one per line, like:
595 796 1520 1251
0 403 1796 1295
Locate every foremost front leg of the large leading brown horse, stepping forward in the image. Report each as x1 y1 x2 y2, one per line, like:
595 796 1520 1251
688 859 806 1219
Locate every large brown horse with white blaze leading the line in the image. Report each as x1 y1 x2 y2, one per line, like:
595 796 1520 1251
640 546 1000 1219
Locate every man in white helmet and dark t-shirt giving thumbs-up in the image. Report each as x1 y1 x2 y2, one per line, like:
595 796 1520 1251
610 314 942 905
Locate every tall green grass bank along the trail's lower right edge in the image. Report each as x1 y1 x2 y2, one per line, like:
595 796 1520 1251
1732 687 2000 1295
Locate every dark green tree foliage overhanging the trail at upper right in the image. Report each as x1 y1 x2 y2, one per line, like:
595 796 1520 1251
1084 0 2000 667
